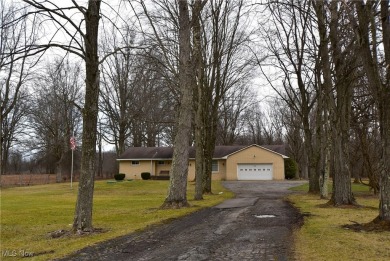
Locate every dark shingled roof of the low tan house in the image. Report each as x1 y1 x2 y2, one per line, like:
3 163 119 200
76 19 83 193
118 145 286 160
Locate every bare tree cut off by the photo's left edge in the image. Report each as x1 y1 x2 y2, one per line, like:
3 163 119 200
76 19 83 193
0 1 36 174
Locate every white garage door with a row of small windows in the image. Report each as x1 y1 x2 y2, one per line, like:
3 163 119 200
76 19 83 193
237 163 273 180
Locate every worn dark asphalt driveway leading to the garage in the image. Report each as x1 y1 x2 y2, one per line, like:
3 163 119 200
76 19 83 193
62 181 304 261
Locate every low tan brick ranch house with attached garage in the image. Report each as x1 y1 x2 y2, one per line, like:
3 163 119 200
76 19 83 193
118 145 288 180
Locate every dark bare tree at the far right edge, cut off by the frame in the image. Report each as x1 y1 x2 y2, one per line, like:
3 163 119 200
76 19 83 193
355 1 390 224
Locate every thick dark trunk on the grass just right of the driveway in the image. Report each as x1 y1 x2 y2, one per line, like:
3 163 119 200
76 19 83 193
329 1 356 206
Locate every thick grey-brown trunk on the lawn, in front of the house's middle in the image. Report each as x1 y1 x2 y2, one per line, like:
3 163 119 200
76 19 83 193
162 0 193 208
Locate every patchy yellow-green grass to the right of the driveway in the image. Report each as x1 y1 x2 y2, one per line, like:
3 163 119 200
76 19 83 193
289 184 390 261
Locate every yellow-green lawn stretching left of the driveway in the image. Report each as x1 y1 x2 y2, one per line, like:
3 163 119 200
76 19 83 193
0 180 233 260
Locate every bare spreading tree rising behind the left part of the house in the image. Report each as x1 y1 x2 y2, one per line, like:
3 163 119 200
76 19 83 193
100 36 174 155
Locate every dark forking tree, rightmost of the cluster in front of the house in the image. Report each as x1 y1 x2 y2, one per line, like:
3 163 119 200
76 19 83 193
202 0 244 194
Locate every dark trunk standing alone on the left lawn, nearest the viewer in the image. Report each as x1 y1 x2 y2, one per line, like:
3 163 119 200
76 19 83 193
73 0 101 233
